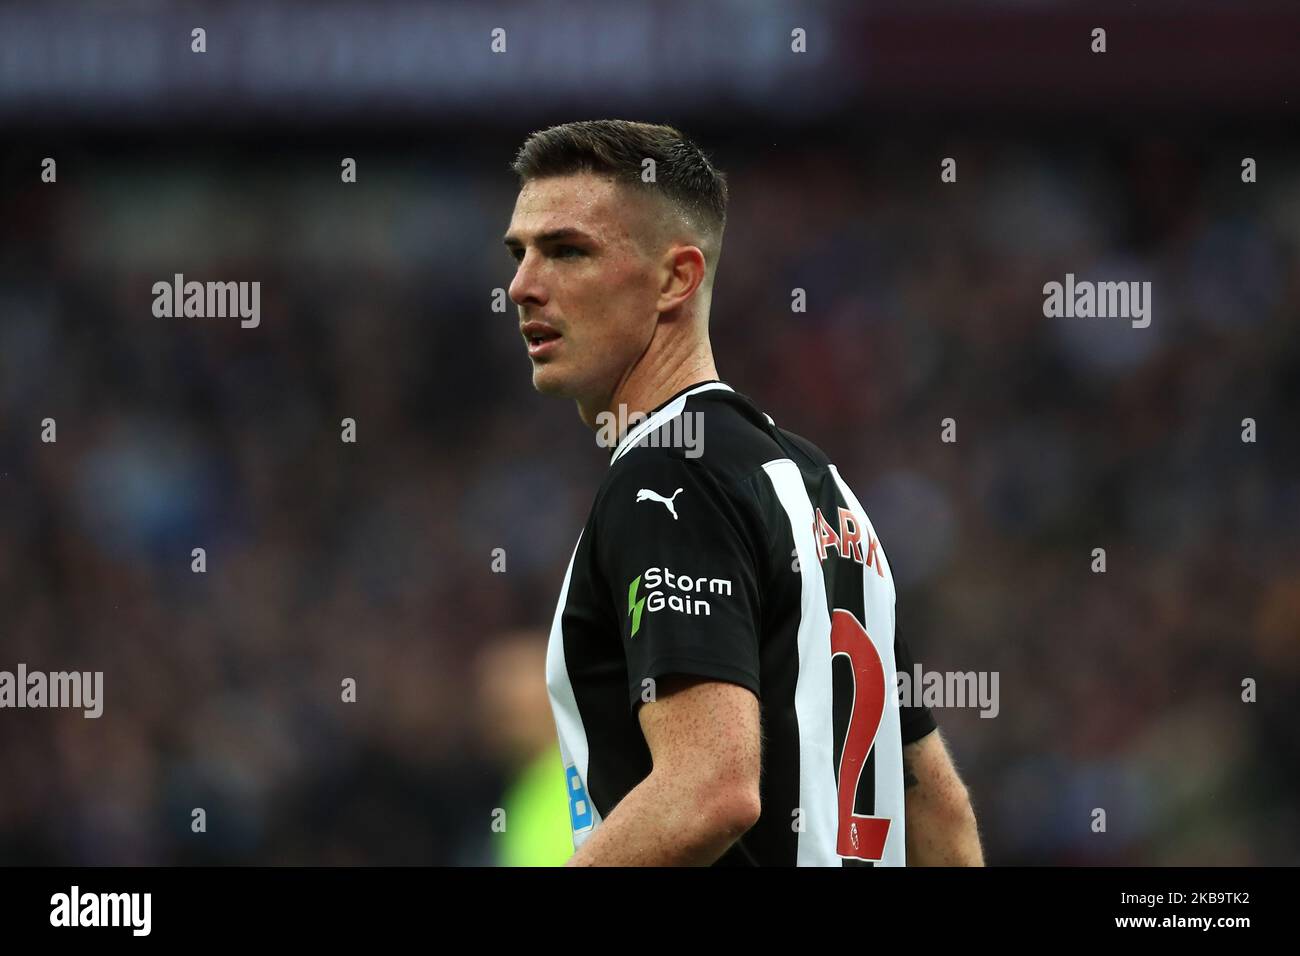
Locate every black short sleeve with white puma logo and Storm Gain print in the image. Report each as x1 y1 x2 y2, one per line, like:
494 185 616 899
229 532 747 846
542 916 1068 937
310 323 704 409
595 449 761 711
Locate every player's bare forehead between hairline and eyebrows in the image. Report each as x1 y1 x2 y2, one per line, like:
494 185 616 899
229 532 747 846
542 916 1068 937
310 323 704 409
510 173 646 242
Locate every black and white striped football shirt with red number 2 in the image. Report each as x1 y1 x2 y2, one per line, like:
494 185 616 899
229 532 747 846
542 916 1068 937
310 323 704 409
546 381 935 866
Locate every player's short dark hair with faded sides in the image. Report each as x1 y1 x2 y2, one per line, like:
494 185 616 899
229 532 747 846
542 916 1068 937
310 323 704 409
511 120 727 256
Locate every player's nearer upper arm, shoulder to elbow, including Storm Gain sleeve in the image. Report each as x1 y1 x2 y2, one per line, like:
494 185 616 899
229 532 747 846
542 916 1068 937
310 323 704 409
595 449 762 836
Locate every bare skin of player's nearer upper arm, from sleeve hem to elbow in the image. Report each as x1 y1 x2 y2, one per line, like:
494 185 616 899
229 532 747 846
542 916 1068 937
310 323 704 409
637 675 762 826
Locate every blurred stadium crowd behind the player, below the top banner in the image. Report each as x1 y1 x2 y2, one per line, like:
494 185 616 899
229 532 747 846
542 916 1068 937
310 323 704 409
0 129 1300 865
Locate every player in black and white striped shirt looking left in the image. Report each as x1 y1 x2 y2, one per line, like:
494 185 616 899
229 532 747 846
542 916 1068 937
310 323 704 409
504 121 983 866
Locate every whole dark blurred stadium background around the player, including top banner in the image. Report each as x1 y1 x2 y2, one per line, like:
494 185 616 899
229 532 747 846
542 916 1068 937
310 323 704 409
0 3 1300 865
